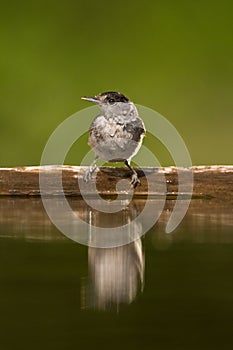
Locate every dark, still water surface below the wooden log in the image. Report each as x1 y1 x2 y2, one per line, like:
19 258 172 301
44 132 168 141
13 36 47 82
0 198 233 350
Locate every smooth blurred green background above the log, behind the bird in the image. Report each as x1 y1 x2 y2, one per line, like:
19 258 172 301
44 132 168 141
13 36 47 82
0 0 233 166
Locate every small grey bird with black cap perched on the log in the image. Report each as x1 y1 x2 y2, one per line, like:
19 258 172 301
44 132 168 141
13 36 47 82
82 91 146 188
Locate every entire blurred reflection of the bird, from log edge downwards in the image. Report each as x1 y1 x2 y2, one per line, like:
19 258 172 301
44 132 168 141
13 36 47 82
79 201 145 310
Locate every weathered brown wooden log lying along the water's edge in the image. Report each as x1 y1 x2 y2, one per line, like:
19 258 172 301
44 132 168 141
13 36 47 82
0 166 233 201
